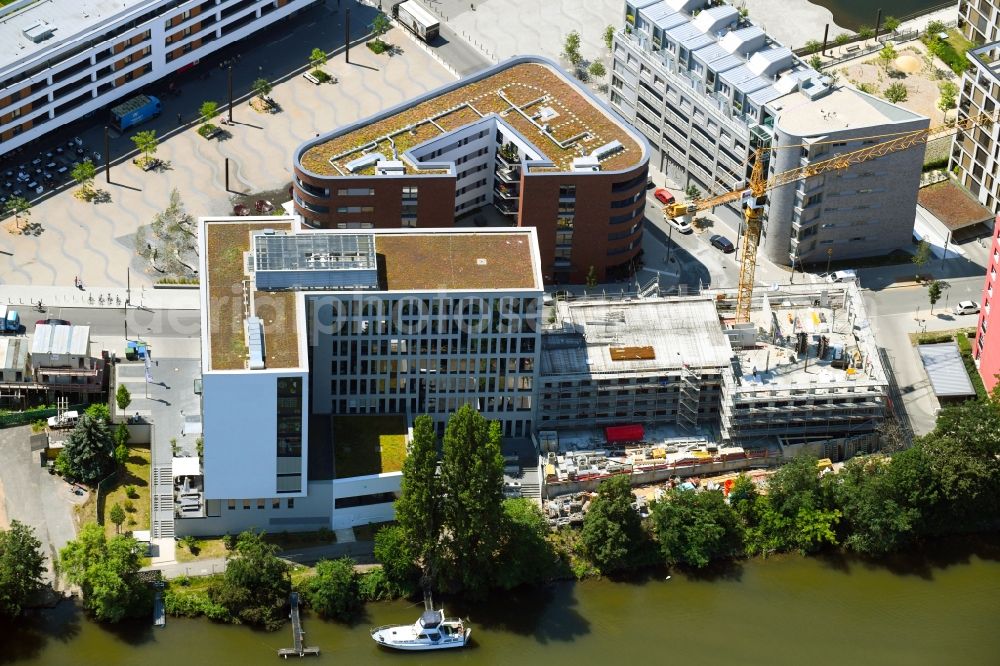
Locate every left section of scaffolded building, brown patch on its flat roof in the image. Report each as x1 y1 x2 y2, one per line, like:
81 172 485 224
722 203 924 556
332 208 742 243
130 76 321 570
538 296 733 432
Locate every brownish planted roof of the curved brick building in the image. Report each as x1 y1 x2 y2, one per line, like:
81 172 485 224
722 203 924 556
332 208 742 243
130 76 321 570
299 60 644 176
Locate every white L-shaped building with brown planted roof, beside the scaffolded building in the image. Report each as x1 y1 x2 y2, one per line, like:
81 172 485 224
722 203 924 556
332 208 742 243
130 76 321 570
176 217 542 534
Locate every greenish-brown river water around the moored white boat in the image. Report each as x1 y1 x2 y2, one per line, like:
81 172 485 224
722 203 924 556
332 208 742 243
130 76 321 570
0 540 1000 666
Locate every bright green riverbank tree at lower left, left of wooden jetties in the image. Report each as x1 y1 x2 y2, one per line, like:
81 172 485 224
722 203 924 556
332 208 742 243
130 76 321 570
59 523 152 623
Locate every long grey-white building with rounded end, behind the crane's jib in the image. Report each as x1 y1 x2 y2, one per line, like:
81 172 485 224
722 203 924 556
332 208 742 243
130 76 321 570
611 0 929 266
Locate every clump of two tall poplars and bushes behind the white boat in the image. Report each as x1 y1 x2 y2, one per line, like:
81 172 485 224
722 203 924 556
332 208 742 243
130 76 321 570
375 405 558 598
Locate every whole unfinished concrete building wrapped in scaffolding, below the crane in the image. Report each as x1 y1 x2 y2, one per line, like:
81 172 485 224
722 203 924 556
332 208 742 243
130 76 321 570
538 283 888 447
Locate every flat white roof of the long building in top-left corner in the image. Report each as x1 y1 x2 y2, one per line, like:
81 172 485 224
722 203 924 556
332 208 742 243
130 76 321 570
0 0 152 76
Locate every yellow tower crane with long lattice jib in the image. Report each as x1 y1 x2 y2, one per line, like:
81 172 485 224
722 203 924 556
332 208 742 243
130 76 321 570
663 113 996 323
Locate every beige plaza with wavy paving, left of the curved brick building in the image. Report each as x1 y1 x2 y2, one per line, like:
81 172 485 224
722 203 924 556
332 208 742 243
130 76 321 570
0 3 454 288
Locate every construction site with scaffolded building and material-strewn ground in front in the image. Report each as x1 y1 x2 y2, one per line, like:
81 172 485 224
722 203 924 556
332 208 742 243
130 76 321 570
537 282 889 498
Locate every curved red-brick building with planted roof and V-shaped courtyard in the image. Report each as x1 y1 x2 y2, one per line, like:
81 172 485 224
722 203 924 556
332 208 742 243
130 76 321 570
293 56 649 283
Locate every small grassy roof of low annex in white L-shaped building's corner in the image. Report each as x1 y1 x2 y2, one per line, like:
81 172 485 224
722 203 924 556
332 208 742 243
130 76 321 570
333 416 406 479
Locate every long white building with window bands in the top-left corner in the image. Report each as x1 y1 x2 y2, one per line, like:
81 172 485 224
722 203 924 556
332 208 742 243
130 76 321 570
0 0 317 154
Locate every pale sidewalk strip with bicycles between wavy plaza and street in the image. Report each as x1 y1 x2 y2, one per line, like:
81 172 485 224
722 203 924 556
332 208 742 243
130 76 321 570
0 284 201 310
